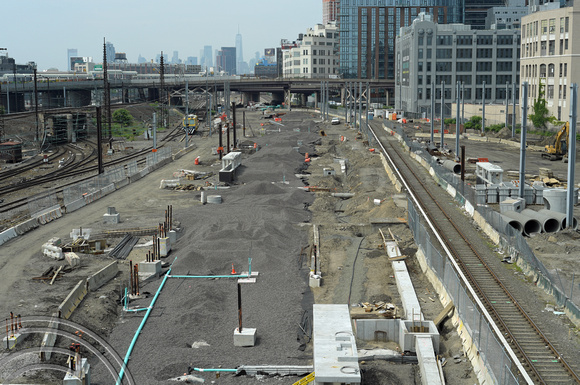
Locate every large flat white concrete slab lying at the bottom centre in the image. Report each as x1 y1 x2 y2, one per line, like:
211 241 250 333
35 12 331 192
313 304 361 384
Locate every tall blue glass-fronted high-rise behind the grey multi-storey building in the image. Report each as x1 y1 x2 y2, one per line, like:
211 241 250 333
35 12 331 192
339 0 464 80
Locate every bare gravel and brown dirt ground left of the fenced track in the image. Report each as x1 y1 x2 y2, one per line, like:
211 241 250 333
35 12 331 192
0 108 476 385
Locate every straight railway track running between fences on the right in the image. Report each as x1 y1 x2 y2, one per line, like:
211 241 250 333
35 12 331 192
371 124 580 384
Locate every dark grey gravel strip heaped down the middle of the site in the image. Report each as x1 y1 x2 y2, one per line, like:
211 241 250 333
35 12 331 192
94 121 318 384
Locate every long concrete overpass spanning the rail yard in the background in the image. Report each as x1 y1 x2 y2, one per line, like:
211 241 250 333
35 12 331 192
0 75 394 113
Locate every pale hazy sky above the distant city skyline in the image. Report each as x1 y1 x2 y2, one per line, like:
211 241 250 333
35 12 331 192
0 0 322 71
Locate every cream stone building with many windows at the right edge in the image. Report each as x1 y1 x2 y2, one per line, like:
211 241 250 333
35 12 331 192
520 3 580 121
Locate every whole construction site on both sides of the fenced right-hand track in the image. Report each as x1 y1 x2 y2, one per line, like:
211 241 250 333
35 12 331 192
0 103 580 385
